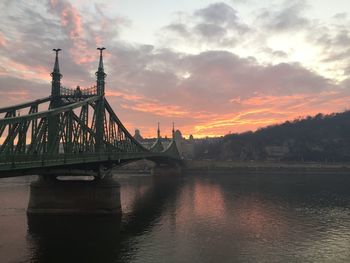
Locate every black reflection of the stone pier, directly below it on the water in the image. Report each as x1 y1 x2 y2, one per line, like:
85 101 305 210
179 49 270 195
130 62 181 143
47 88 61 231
28 216 121 262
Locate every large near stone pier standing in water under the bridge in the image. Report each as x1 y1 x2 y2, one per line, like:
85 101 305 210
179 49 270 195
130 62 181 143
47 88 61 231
27 175 122 215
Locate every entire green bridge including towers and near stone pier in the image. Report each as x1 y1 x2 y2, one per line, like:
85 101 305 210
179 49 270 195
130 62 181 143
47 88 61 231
0 48 181 216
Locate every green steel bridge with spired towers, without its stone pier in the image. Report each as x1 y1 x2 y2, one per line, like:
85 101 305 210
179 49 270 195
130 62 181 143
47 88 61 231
0 48 181 178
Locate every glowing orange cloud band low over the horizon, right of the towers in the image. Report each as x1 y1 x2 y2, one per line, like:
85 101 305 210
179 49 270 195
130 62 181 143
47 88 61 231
103 87 350 138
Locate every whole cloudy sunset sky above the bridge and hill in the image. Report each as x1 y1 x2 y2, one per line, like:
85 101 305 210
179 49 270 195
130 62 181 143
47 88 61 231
0 0 350 138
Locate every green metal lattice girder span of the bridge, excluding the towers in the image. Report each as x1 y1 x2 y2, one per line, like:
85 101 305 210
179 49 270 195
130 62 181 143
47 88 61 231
0 97 179 176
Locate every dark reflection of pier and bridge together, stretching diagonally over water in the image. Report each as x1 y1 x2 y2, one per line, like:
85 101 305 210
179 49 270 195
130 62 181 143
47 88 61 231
28 175 179 262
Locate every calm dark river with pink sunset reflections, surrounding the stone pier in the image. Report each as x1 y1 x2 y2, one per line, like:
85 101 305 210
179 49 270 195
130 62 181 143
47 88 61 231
0 173 350 263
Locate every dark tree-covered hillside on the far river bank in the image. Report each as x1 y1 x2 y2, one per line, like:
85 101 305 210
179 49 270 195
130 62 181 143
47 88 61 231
195 111 350 162
